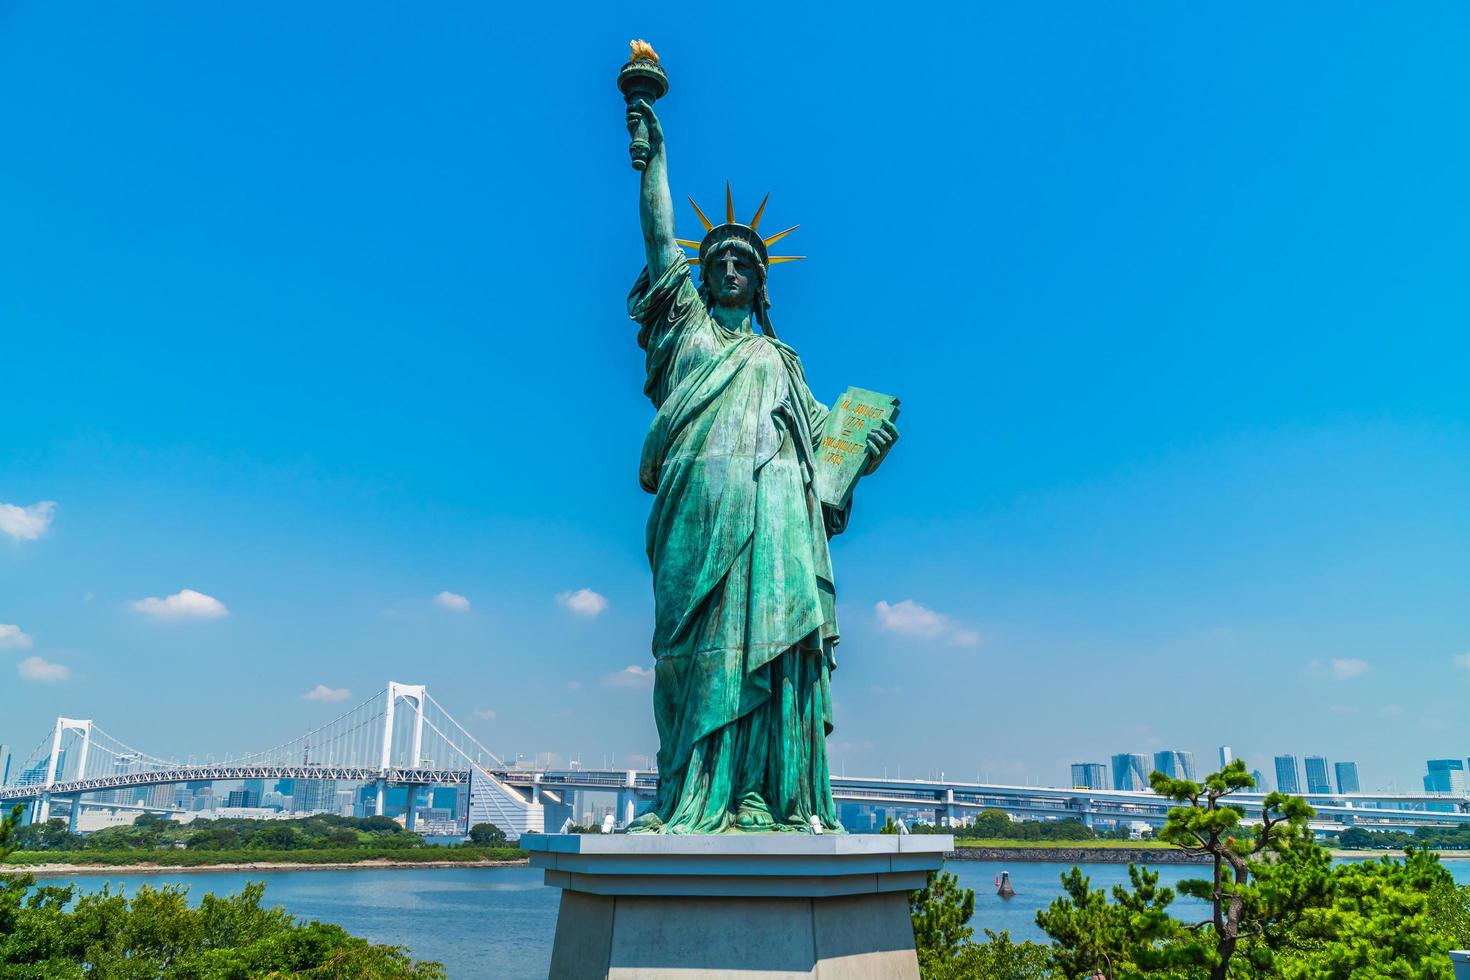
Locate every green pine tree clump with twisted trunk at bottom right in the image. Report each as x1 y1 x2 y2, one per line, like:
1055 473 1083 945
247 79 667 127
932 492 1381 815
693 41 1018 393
1036 763 1452 980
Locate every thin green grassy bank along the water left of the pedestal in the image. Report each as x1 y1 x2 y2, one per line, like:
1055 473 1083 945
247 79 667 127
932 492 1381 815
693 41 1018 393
4 846 526 868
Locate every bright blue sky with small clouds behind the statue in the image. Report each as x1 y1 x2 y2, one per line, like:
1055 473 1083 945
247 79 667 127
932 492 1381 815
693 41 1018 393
0 3 1470 788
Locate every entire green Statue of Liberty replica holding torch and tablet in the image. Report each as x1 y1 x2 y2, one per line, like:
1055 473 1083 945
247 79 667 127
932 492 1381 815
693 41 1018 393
619 43 898 835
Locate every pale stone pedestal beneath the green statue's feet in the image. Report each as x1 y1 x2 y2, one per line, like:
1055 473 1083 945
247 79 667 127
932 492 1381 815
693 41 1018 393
520 833 954 980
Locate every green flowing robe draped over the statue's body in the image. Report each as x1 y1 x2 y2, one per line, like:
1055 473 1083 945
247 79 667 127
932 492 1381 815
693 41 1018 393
628 259 847 833
